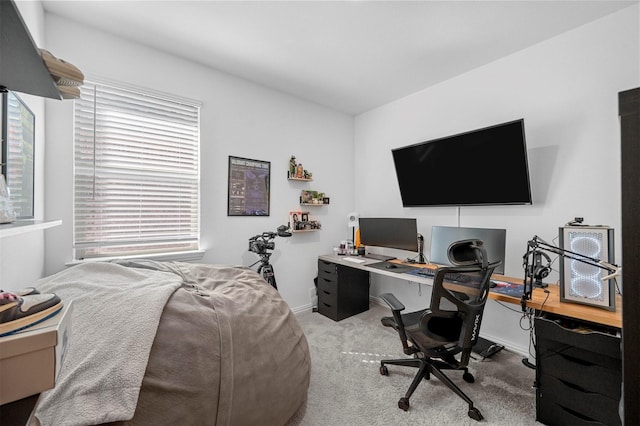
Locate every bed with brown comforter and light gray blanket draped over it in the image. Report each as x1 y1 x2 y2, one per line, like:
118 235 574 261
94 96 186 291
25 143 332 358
30 261 311 426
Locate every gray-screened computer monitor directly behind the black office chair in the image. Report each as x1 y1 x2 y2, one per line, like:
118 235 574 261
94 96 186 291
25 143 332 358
429 226 507 274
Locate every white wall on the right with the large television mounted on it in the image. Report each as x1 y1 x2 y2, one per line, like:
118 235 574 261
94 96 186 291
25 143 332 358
355 5 640 351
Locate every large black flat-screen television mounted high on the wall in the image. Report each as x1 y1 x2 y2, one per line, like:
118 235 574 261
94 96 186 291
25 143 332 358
392 119 531 207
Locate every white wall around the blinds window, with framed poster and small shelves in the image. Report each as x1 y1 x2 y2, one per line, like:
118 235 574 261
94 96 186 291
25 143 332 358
41 14 353 309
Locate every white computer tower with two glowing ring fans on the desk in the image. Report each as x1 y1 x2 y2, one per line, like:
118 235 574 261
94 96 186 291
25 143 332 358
559 226 616 311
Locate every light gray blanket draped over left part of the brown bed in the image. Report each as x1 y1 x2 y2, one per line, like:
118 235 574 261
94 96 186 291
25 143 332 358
36 263 182 425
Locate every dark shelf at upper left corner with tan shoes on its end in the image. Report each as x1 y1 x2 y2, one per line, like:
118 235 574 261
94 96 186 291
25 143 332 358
0 0 62 100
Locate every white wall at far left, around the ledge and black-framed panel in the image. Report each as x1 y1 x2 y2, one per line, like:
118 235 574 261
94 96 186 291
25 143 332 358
0 2 46 290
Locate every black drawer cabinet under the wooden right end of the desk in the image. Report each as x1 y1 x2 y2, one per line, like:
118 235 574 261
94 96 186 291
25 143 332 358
535 314 622 425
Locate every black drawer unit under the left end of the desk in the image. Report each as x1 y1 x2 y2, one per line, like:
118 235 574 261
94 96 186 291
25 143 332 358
318 259 369 321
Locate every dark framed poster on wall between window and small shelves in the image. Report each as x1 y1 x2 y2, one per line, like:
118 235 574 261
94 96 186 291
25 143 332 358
227 156 271 216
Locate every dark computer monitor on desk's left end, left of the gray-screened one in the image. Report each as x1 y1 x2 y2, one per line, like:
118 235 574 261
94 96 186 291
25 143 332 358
358 217 418 252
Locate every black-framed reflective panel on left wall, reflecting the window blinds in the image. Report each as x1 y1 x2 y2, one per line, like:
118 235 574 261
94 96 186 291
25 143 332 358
0 91 35 219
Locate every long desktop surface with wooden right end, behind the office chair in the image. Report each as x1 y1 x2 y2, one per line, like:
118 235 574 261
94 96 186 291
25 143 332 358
320 255 622 329
